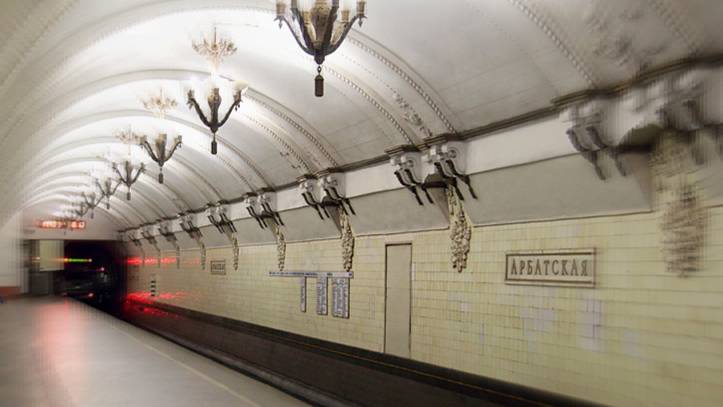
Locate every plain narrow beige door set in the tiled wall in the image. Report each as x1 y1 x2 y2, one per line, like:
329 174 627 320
384 244 412 358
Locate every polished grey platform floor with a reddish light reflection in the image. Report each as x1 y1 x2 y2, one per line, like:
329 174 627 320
0 297 305 407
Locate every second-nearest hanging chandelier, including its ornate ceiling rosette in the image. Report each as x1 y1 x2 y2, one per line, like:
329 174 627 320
185 28 248 154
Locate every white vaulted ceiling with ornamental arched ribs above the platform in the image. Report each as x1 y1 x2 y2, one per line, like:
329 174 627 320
0 0 723 231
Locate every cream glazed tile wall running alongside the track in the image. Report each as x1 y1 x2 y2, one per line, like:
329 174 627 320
130 208 723 406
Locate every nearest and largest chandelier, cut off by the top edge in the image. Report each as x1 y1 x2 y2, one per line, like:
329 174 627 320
275 0 366 97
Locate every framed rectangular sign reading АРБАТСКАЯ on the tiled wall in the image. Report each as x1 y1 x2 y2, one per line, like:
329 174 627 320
505 249 595 287
